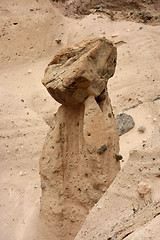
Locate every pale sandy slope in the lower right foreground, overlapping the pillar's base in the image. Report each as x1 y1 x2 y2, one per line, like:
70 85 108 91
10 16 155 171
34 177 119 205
75 126 160 240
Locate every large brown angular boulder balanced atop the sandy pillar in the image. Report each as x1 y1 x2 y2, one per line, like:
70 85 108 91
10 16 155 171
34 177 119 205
43 38 117 105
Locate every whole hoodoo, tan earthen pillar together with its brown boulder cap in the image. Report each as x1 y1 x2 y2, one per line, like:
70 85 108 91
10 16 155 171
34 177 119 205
39 39 120 240
